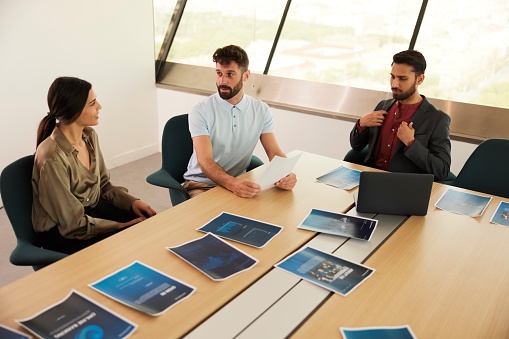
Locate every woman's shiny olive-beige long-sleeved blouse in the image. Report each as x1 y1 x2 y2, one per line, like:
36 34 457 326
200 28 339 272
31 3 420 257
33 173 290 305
32 126 136 240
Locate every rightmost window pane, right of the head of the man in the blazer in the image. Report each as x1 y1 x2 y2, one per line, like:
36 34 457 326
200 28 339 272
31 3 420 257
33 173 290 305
415 0 509 108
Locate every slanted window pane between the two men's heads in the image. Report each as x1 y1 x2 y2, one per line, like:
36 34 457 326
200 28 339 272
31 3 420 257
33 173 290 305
268 0 421 91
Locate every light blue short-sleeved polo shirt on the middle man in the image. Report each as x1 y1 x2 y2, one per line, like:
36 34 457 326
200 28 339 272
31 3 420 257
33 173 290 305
184 93 274 185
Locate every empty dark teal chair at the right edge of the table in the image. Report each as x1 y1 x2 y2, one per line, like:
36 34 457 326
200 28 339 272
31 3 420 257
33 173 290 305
451 139 509 198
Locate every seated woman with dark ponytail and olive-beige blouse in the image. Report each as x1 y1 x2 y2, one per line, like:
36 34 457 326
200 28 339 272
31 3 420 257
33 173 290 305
32 77 156 254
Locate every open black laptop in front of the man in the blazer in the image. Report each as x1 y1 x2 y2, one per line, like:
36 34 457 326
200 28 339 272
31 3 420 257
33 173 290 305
356 172 434 215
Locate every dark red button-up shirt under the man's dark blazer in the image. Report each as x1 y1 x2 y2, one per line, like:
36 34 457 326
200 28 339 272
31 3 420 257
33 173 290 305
375 101 422 171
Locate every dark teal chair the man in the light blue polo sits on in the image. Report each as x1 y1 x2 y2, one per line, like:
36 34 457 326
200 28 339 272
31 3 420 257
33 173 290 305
147 114 263 206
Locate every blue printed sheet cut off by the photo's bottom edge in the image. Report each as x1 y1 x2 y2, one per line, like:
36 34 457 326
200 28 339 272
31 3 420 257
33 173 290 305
339 325 417 339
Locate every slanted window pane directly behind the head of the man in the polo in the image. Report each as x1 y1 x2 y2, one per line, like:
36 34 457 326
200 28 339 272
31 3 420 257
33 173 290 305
167 0 286 73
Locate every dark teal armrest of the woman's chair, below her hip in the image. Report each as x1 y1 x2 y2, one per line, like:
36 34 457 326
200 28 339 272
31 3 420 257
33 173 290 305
9 240 67 266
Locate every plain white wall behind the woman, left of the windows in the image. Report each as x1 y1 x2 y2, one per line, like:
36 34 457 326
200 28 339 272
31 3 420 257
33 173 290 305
0 0 160 175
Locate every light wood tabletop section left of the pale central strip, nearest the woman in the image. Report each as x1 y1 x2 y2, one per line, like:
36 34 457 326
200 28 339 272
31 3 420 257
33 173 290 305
0 151 362 338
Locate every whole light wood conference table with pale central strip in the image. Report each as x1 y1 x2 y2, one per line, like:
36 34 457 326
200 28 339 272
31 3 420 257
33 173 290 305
0 151 509 338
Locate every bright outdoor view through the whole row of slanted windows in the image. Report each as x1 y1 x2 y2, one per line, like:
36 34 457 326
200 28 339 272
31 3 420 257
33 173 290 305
154 0 509 108
